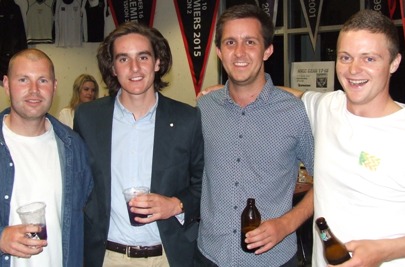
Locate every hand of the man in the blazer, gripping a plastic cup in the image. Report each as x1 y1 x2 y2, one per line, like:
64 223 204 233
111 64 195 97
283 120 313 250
129 193 182 223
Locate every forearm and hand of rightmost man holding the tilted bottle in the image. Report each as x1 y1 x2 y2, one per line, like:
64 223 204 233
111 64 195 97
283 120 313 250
337 237 405 267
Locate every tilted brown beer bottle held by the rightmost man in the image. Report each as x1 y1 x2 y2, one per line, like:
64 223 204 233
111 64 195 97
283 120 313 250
315 217 351 265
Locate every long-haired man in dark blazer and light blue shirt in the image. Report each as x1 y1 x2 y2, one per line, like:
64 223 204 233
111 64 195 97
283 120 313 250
74 22 204 267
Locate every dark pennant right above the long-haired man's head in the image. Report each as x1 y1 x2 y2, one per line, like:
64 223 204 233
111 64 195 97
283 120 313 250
108 0 156 27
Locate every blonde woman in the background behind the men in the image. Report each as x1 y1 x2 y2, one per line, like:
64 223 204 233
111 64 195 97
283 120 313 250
58 74 99 128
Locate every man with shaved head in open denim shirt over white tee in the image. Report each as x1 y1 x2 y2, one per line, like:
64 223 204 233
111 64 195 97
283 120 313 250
0 49 93 267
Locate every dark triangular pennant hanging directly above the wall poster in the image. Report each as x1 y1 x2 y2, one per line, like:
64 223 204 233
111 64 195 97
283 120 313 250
300 0 323 51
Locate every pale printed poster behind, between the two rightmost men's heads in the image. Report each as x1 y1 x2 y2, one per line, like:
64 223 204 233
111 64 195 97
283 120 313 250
291 61 335 92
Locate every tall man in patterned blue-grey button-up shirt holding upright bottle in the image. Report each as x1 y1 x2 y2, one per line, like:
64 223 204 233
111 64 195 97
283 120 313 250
195 5 314 267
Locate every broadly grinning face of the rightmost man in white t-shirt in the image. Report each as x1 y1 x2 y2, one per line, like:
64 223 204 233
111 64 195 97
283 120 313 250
336 30 401 114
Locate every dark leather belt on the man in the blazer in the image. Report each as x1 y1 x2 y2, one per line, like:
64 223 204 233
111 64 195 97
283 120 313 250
107 241 162 258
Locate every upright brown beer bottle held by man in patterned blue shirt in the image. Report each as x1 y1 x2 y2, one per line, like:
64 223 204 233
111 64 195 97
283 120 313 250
240 198 261 253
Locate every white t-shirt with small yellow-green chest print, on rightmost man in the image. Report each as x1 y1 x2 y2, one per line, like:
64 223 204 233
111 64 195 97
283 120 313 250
302 91 405 267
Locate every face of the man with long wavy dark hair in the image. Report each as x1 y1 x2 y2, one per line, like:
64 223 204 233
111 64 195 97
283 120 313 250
113 33 159 99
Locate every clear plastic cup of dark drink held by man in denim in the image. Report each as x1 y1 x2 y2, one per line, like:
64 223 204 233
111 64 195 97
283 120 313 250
17 202 48 240
